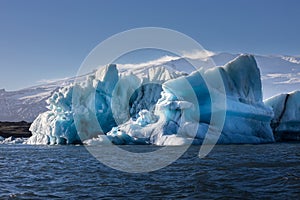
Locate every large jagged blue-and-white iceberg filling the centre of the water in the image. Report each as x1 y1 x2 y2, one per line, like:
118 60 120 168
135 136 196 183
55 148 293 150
27 55 274 145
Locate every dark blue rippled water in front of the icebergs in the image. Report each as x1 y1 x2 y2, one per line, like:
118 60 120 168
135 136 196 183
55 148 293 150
0 143 300 199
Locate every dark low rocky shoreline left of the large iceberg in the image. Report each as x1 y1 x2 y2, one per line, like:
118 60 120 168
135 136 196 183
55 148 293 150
0 121 32 138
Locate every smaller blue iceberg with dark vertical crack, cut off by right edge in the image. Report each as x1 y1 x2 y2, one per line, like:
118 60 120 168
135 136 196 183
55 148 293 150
265 91 300 141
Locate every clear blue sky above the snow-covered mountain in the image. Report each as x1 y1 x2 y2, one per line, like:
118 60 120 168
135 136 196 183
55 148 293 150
0 0 300 90
